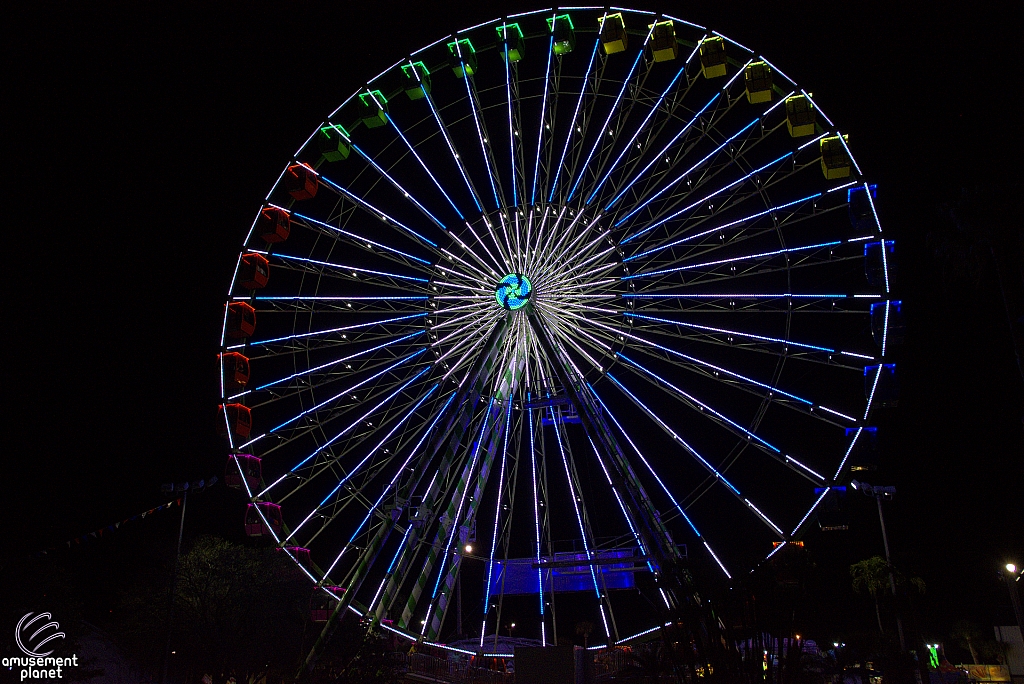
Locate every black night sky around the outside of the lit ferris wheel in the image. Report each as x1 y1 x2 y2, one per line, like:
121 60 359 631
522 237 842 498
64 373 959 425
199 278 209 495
0 0 1024 647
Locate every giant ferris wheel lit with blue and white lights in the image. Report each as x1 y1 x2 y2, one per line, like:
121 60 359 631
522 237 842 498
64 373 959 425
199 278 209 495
214 8 902 648
